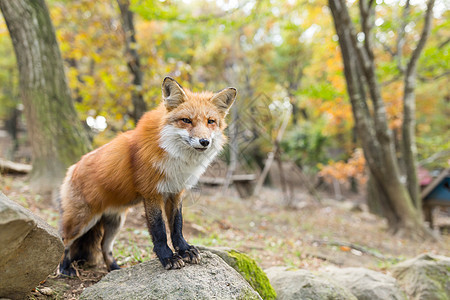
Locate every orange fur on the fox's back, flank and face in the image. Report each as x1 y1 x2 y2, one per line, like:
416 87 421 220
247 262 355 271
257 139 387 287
61 77 235 251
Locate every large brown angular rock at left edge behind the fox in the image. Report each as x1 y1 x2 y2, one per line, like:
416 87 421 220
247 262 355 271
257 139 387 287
0 192 64 299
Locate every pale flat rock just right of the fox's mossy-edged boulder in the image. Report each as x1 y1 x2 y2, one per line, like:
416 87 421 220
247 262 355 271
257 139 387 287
265 267 356 300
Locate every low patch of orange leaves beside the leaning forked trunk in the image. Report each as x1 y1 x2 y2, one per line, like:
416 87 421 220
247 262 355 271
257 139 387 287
318 148 367 184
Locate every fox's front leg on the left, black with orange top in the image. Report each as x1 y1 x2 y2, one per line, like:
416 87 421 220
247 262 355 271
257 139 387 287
144 196 184 270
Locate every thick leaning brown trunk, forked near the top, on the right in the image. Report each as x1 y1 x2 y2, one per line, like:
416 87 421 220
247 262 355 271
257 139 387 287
329 0 429 237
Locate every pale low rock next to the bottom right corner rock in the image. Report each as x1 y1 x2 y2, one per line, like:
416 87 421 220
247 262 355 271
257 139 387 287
321 267 406 300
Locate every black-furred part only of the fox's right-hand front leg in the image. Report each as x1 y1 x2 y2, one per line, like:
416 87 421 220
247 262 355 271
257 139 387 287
166 202 200 264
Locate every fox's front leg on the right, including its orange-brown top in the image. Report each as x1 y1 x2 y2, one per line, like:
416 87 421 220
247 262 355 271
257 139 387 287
165 194 200 264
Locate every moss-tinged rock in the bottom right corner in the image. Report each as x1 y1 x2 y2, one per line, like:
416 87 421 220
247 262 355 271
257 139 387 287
391 254 450 300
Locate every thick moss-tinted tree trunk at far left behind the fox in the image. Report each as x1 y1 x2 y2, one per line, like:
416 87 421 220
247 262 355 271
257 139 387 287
0 0 90 191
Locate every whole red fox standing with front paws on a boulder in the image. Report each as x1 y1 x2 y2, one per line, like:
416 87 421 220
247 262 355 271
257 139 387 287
60 77 236 276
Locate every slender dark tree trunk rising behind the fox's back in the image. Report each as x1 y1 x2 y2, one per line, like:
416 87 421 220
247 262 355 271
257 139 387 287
117 0 147 124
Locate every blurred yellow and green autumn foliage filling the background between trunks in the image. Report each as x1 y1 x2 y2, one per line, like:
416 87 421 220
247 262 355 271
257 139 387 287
0 0 450 183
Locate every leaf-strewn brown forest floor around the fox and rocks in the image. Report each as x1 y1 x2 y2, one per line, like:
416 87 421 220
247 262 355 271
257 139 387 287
0 176 450 299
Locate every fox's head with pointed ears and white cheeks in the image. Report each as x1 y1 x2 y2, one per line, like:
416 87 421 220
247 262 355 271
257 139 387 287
160 77 236 156
